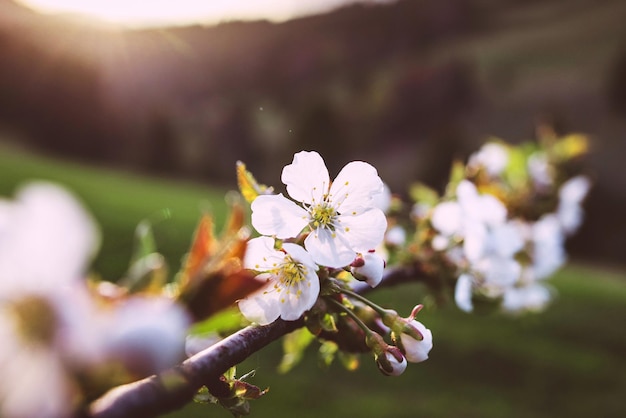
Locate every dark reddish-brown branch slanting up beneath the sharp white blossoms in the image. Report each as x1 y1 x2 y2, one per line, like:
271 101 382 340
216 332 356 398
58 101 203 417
85 266 427 418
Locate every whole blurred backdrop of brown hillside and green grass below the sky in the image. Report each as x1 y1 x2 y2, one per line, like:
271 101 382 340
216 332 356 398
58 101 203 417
0 0 626 417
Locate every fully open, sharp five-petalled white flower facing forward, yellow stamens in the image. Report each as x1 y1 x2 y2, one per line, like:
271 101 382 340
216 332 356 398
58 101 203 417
252 151 387 268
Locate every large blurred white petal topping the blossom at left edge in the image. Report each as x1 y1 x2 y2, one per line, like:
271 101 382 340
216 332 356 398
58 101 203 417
0 182 98 293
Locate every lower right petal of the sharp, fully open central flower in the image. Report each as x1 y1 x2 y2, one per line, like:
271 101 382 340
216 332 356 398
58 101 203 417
335 208 387 251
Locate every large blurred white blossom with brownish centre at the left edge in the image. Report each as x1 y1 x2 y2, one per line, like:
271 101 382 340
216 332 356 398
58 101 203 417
0 183 98 418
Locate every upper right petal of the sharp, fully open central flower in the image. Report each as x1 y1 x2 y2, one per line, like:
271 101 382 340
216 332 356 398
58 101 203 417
329 161 384 213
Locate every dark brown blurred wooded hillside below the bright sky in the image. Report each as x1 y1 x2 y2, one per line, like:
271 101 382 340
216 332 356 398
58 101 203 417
0 0 626 259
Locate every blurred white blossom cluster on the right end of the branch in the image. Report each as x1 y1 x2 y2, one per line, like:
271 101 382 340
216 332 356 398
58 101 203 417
416 139 590 313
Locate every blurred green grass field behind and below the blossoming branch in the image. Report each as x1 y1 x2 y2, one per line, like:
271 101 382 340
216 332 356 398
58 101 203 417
0 148 626 418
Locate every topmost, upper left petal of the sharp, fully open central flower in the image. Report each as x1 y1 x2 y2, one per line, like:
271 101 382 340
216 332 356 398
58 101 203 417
281 151 330 204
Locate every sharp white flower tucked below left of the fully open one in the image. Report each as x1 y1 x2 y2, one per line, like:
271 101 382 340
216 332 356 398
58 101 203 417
239 237 320 325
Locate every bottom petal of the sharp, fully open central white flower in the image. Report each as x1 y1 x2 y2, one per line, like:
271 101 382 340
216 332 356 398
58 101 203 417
304 225 356 268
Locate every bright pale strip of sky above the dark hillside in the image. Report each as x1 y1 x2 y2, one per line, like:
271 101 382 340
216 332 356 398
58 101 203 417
17 0 391 28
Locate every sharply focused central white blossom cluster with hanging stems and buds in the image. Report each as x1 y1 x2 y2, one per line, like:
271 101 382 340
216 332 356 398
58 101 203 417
239 151 432 374
